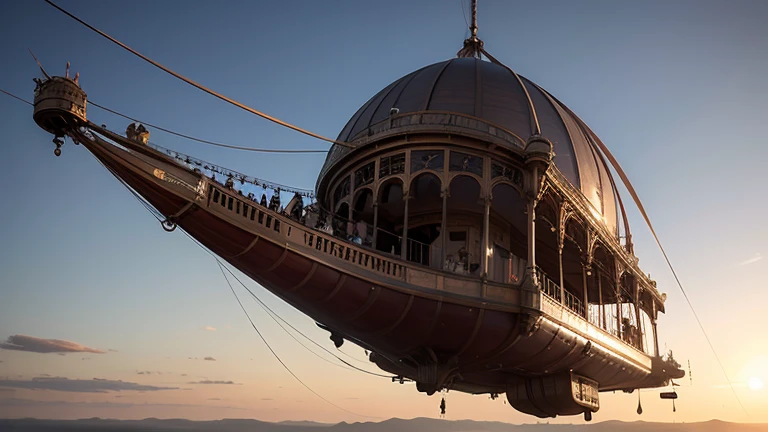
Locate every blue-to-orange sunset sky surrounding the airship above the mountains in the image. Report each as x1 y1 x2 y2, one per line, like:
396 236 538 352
0 0 768 423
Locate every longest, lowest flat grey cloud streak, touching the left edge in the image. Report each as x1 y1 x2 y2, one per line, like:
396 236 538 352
0 377 178 393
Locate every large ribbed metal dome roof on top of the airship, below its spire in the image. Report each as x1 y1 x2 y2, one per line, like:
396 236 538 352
318 58 619 235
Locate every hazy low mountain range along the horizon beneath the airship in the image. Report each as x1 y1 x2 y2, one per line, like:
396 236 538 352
0 418 768 432
